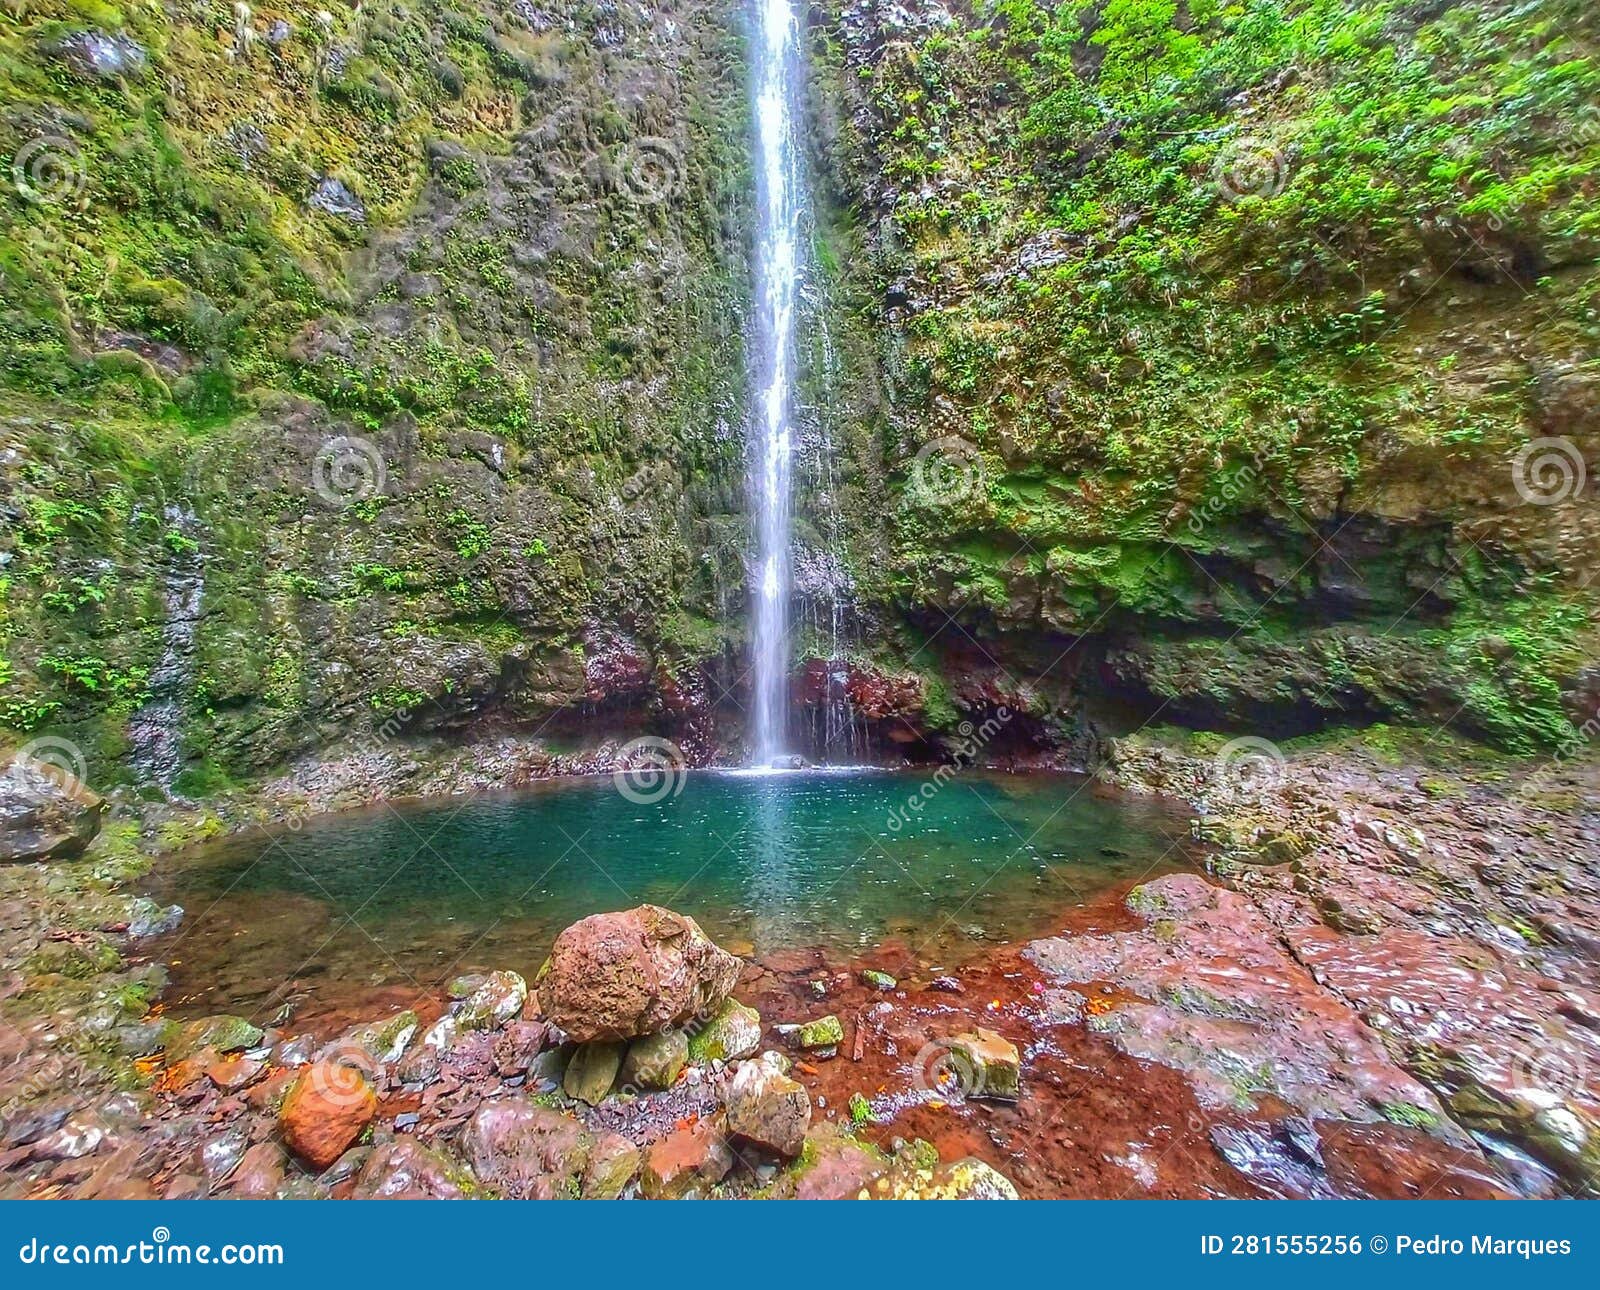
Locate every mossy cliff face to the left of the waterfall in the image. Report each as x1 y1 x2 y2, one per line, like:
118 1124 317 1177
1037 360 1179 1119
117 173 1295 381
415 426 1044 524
0 0 749 791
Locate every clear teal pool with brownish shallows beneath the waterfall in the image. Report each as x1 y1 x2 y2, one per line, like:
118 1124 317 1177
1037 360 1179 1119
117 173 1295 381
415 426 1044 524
154 771 1190 1016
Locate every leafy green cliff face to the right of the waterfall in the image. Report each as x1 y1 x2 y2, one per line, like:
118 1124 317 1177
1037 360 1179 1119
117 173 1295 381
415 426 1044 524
819 0 1600 761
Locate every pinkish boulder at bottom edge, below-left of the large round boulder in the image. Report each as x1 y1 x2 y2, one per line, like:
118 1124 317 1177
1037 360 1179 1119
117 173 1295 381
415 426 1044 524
461 1098 601 1200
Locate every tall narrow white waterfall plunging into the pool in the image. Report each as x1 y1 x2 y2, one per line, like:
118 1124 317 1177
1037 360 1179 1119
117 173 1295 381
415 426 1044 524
750 0 802 765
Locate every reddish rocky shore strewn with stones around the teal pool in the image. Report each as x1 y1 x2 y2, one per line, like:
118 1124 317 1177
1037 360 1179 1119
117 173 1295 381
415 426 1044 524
0 736 1600 1197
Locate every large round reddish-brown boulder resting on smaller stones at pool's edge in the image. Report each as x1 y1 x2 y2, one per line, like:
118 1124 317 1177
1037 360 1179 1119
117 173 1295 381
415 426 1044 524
538 904 742 1042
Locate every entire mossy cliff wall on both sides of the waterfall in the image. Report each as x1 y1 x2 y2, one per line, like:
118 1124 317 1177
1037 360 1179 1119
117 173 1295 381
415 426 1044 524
0 0 1600 792
